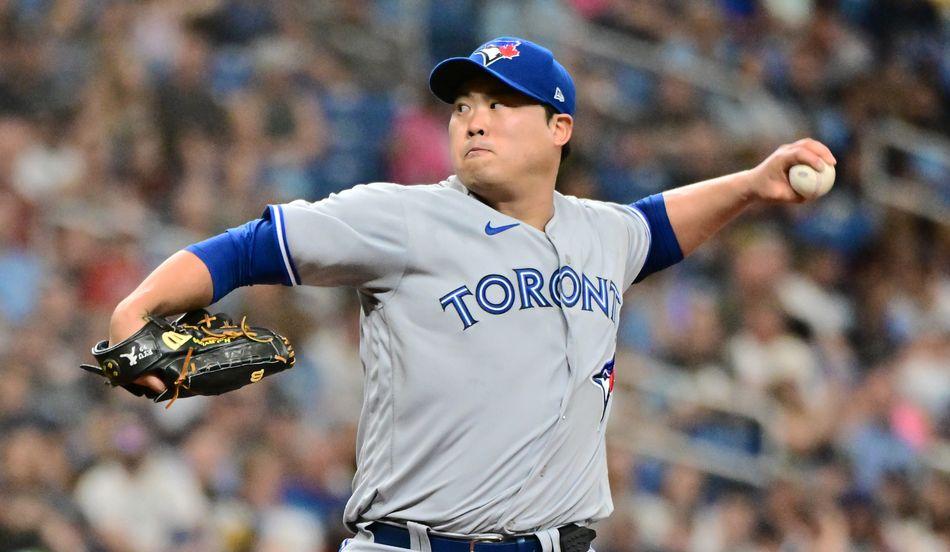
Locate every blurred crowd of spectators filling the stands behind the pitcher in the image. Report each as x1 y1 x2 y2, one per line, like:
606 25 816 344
0 0 950 552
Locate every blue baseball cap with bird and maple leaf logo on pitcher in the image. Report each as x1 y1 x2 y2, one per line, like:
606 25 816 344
429 36 574 116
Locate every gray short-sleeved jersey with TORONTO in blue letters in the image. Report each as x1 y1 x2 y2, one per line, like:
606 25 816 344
271 176 650 533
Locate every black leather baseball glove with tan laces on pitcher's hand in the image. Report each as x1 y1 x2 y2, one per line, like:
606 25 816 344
81 309 294 408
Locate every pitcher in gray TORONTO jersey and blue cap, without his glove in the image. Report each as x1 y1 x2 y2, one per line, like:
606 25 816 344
96 37 835 552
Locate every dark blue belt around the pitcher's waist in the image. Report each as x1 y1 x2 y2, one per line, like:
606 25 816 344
367 522 597 552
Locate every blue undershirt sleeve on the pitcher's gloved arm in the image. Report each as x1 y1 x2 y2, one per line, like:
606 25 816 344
185 207 292 303
